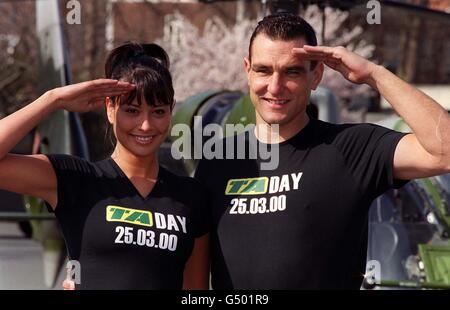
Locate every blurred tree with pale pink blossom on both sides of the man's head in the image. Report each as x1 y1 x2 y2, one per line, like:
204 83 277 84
157 5 374 116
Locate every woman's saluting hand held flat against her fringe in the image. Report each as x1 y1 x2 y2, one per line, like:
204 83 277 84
49 79 135 113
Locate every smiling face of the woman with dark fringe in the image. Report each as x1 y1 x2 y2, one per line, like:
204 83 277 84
107 98 171 157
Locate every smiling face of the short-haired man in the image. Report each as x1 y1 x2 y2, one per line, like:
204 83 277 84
244 34 323 130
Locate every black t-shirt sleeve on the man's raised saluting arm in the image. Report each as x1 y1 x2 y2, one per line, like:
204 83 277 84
335 124 408 197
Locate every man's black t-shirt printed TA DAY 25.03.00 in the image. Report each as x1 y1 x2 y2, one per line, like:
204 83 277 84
196 119 405 289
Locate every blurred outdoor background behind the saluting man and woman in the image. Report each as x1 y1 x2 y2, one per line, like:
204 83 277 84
0 0 450 289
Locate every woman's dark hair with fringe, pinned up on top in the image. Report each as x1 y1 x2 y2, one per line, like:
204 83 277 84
105 42 174 108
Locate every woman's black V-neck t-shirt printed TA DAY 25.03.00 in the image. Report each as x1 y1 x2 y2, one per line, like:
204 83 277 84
48 155 209 289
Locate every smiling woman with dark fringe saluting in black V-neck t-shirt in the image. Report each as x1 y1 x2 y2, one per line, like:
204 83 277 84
0 43 208 289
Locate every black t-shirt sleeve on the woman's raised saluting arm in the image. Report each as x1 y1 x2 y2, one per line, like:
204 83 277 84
46 155 90 217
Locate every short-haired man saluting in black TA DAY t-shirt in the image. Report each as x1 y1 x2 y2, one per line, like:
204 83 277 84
196 14 450 289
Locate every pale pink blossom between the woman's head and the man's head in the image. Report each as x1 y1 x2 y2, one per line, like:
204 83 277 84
157 13 255 100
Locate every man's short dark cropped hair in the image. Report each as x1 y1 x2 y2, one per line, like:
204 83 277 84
248 13 317 68
